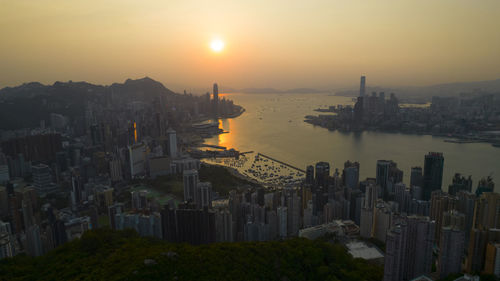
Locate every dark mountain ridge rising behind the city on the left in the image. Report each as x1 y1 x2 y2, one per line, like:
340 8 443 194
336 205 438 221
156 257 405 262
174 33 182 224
0 77 181 130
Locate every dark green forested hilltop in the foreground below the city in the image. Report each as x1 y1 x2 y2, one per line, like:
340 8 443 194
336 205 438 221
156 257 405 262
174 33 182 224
0 229 383 281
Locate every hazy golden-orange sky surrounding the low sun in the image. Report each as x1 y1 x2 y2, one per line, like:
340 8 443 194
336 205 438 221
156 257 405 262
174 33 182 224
0 0 500 90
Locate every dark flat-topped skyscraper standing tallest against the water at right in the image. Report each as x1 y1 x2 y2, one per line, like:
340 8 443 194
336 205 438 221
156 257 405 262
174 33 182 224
423 152 444 200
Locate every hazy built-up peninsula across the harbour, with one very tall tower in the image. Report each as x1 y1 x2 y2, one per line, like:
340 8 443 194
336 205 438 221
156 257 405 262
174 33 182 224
304 77 500 147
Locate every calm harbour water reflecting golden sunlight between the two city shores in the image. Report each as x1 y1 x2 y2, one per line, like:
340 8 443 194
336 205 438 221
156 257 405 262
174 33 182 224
206 93 500 191
